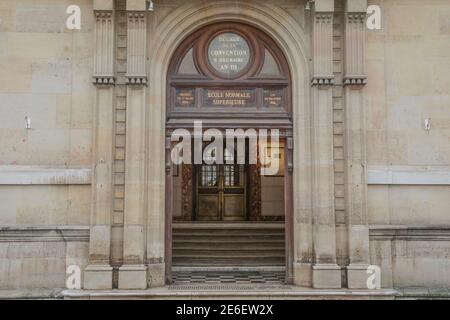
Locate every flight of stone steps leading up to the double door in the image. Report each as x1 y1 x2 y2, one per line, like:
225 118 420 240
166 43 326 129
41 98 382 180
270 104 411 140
172 223 285 267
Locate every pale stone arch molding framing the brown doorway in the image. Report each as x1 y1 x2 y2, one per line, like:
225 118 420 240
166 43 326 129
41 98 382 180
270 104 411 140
141 1 313 286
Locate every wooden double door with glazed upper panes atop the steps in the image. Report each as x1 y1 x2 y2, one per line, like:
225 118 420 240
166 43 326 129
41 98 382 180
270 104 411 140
195 164 247 221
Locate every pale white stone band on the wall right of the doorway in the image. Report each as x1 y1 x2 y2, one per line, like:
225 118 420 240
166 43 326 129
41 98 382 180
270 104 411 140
367 166 450 185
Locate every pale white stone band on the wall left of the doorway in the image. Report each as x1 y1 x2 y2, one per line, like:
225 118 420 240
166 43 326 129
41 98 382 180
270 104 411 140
0 166 91 185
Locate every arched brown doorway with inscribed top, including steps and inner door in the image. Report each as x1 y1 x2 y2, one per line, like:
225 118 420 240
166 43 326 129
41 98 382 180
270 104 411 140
166 22 293 281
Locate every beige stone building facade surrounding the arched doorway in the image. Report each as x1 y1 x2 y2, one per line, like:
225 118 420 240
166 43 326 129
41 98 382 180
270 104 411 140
0 0 450 295
